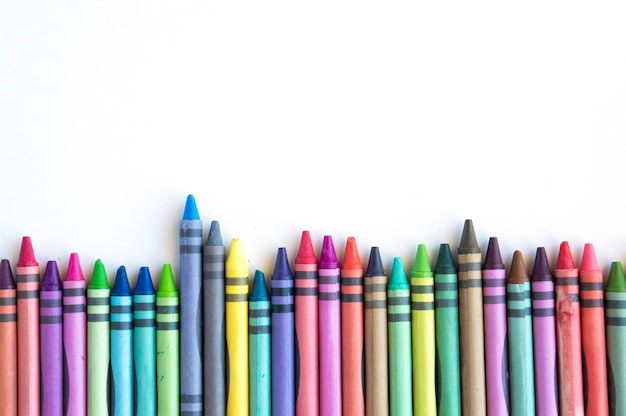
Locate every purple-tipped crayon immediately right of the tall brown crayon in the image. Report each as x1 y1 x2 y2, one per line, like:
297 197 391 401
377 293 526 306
482 237 509 416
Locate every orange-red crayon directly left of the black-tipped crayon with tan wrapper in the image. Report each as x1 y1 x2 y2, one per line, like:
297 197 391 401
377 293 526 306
340 237 365 416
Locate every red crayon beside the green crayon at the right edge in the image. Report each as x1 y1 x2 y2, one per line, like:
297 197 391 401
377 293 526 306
578 243 609 416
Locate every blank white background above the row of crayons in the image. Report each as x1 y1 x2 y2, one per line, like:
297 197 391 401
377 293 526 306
0 0 626 283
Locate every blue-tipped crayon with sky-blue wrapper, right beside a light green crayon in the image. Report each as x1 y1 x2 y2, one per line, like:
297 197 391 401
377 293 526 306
111 266 134 416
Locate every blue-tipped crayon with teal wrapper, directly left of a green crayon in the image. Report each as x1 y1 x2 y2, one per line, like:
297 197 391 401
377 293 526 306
133 267 156 416
